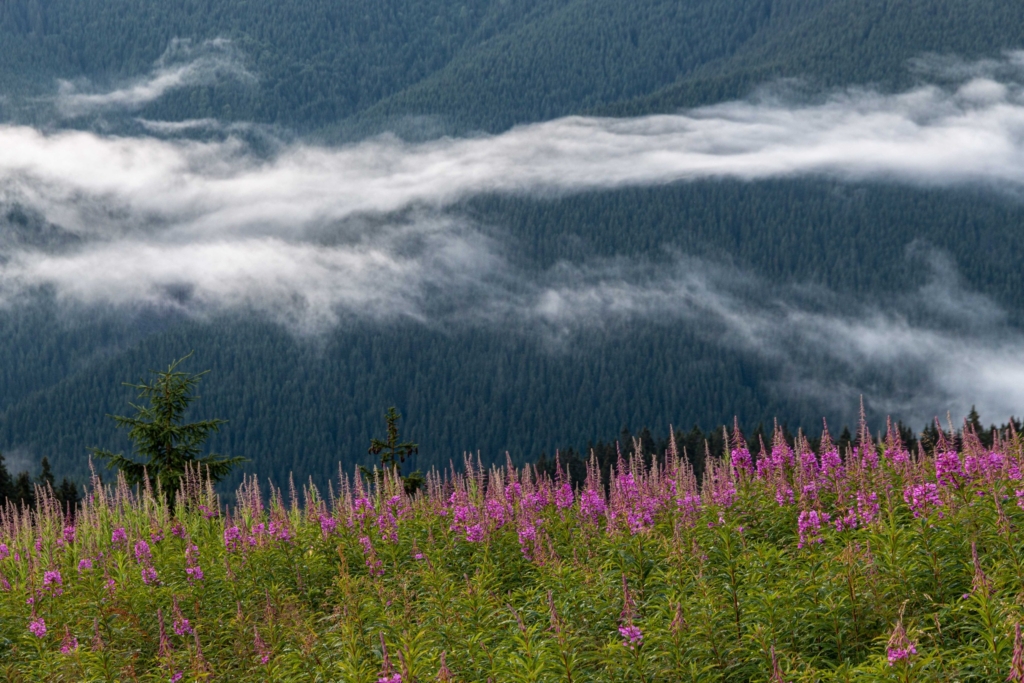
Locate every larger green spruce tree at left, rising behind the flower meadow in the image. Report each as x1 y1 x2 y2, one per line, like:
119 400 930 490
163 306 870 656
92 353 245 499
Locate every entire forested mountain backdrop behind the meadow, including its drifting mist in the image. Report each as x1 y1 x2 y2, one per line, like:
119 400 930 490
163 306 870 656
0 0 1024 486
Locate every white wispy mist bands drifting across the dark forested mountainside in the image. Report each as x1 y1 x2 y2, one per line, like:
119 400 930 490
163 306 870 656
6 57 1024 419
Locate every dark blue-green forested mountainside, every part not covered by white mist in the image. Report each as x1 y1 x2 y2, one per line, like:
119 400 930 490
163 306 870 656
0 0 1024 486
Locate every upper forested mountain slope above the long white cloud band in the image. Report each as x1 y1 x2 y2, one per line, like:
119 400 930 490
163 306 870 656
0 0 1024 136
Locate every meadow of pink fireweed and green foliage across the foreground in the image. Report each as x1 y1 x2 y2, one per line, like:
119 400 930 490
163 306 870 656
0 425 1024 683
